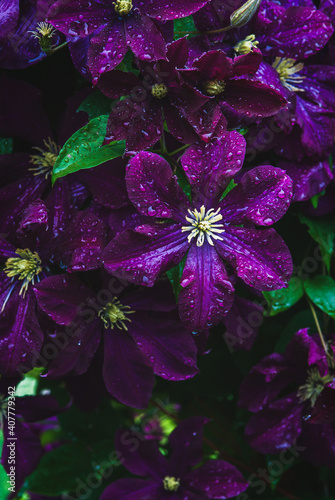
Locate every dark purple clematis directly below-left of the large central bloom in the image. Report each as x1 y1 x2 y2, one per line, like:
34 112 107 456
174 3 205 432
35 275 198 408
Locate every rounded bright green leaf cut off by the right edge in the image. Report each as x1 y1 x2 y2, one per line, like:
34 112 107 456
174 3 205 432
304 275 335 319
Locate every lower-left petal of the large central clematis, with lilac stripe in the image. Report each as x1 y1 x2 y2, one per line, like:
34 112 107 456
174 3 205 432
103 224 189 286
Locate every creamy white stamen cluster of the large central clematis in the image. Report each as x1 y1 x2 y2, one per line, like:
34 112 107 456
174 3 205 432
181 205 225 247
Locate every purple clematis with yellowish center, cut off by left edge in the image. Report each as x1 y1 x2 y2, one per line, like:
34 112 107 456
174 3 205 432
0 179 106 376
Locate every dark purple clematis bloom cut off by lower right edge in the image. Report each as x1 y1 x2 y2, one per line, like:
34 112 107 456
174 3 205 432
239 329 335 467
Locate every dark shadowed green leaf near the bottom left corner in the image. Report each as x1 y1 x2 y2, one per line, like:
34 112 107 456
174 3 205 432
25 439 119 496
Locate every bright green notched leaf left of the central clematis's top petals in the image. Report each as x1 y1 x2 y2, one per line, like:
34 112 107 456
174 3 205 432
52 115 125 183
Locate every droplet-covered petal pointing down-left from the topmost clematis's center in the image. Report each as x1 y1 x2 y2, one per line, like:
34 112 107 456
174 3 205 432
88 19 128 83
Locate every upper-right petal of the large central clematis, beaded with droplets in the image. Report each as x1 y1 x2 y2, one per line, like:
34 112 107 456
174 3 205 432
221 166 293 226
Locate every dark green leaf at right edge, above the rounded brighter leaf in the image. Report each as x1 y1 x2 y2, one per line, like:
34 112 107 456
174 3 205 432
299 214 335 273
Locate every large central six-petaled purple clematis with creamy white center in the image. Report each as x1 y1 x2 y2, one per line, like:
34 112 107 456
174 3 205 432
103 132 292 330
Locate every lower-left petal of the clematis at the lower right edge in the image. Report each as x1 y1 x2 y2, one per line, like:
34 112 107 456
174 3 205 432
245 396 304 454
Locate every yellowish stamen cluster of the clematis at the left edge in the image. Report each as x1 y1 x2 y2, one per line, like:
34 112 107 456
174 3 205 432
4 248 42 297
